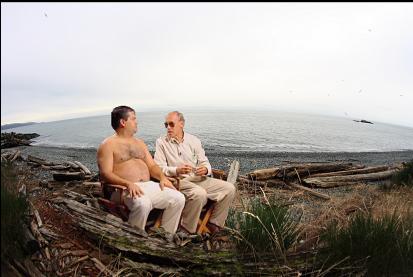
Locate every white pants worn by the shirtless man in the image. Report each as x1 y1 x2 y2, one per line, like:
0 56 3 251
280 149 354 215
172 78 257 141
111 181 185 233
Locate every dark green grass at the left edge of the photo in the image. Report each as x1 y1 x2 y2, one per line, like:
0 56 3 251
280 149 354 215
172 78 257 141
1 162 28 261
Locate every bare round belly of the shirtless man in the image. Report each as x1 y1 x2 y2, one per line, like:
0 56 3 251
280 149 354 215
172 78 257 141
113 159 150 182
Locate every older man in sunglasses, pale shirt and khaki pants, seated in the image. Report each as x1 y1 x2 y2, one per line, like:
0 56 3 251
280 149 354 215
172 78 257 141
155 111 235 234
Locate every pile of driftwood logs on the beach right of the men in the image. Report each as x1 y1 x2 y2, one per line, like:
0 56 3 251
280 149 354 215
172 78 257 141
238 162 399 200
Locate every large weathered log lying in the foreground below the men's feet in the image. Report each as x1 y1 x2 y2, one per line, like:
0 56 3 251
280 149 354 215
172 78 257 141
57 199 243 272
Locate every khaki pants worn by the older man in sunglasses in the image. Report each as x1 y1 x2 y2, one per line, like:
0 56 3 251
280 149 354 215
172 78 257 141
179 176 235 233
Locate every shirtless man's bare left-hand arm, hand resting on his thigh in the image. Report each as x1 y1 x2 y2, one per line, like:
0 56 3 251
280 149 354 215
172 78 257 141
97 142 143 197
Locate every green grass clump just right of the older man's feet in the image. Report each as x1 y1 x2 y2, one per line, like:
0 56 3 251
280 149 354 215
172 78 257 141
227 194 300 261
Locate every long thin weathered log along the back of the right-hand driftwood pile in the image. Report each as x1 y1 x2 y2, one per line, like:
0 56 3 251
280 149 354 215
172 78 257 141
247 163 354 181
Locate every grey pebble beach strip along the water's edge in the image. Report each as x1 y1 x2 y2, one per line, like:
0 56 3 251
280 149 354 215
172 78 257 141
6 145 413 174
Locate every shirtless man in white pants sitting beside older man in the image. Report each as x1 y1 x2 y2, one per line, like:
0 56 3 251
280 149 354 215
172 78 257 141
97 106 185 233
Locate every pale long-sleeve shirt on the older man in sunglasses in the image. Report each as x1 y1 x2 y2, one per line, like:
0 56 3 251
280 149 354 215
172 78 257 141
154 133 212 176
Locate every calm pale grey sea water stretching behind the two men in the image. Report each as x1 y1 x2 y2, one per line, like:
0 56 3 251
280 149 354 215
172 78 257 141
5 111 413 152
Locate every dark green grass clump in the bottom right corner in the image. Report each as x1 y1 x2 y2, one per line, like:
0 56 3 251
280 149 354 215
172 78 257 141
322 213 413 276
